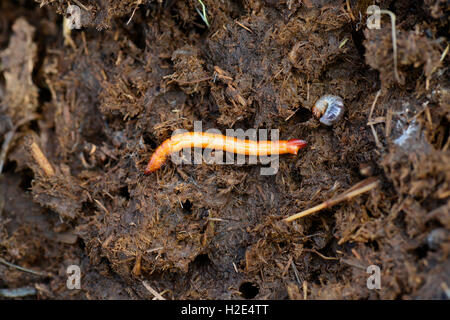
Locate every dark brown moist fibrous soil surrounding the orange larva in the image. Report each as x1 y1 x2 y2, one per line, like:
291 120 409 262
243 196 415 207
0 0 450 299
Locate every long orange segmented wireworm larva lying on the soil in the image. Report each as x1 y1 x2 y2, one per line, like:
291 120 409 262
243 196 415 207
144 132 307 174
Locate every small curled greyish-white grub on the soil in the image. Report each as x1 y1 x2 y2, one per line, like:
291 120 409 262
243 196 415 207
312 94 345 126
